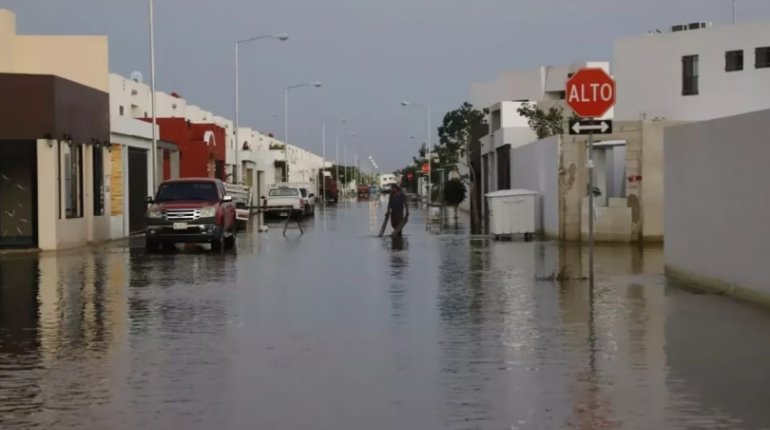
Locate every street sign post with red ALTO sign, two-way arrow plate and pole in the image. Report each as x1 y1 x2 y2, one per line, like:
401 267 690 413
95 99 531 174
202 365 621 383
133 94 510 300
566 68 615 283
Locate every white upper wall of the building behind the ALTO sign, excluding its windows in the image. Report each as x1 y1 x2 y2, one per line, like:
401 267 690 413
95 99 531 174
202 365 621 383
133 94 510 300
612 21 770 121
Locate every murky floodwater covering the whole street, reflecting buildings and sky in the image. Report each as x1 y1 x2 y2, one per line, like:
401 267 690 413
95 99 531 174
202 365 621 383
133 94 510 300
0 202 770 430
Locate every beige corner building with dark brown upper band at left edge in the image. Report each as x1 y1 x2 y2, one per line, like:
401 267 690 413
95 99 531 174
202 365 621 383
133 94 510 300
0 10 110 250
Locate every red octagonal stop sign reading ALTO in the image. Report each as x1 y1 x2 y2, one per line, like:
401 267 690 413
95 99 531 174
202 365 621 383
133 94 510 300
566 68 615 118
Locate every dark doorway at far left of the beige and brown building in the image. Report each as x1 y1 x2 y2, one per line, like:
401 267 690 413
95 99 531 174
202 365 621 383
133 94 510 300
0 140 37 248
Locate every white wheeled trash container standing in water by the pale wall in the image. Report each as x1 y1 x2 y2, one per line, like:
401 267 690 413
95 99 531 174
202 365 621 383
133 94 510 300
486 190 540 241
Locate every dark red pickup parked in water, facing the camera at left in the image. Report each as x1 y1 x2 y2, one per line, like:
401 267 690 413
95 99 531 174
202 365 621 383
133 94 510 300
145 178 237 252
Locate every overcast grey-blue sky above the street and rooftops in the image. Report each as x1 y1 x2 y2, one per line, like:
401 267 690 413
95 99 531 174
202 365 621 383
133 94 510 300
0 0 770 170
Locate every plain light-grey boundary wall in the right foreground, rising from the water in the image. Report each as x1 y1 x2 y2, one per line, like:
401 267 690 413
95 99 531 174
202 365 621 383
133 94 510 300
664 110 770 304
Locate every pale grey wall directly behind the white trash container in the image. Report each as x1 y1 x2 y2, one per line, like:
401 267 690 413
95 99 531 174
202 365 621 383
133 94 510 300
511 136 559 238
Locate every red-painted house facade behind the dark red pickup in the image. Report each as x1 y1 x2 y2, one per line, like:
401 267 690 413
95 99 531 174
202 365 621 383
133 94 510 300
143 118 227 181
